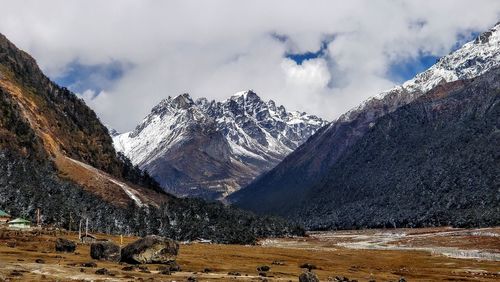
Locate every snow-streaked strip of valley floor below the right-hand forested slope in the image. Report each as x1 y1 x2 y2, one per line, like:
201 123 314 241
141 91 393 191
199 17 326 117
261 227 500 261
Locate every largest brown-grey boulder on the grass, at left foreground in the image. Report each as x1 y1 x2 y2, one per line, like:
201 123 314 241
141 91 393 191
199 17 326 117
121 235 179 264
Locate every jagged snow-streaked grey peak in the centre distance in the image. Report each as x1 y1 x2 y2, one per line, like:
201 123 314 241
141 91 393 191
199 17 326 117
114 91 326 199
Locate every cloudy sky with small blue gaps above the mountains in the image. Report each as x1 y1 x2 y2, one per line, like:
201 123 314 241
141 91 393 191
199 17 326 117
0 0 500 131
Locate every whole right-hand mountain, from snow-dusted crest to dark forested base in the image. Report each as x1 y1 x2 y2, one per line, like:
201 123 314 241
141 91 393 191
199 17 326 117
229 24 500 229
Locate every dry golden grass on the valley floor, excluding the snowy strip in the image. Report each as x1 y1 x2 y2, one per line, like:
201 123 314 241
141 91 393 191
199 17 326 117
0 228 500 281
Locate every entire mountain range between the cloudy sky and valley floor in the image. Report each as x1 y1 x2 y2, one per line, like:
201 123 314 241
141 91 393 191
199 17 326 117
0 19 500 237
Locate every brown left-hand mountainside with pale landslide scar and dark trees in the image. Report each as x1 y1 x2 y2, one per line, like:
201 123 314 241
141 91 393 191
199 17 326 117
0 34 301 243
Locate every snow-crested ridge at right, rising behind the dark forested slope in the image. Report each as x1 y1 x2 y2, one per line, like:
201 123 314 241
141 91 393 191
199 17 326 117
230 24 500 215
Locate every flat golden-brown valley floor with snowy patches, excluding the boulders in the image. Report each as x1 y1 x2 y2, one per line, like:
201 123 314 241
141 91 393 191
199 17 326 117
0 227 500 281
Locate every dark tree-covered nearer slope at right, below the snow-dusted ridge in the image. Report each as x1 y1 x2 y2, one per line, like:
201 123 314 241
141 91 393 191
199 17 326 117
298 68 500 229
